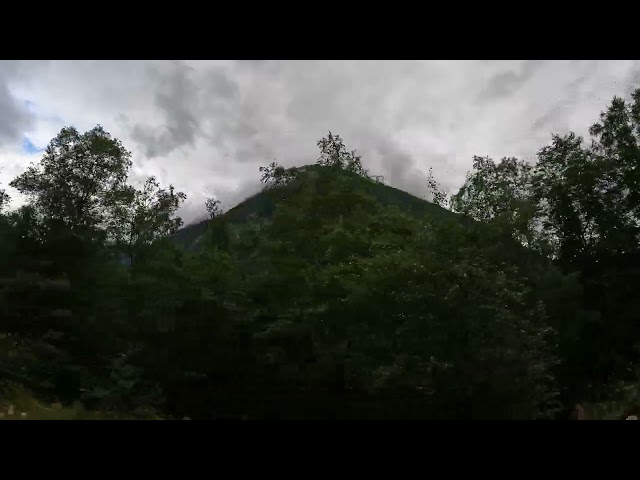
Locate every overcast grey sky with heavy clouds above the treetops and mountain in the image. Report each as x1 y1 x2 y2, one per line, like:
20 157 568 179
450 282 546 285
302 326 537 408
0 60 640 223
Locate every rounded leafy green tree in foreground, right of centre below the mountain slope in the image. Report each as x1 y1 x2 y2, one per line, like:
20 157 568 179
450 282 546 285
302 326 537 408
352 217 557 419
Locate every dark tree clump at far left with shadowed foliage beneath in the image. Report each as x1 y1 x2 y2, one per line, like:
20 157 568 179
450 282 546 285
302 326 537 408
0 127 184 410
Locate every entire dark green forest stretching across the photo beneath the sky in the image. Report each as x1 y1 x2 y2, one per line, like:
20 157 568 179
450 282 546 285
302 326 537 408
0 89 640 419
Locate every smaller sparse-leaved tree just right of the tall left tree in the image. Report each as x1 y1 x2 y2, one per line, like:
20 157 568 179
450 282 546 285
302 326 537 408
107 176 187 265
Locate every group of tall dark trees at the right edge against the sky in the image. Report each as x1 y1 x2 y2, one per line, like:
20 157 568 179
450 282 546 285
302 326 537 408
453 89 640 401
